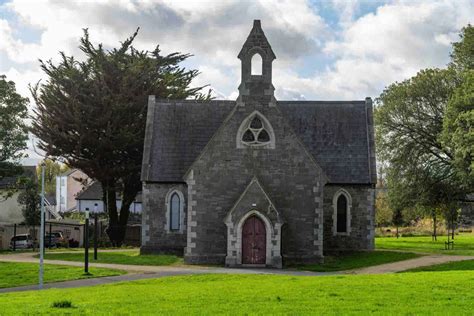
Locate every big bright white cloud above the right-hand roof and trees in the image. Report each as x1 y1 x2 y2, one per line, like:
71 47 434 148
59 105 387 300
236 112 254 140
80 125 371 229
277 1 474 99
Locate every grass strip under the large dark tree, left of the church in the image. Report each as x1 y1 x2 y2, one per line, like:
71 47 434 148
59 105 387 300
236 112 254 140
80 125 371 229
45 250 183 266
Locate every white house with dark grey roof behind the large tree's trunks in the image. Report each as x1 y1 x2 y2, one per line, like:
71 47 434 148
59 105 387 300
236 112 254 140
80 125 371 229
76 182 142 214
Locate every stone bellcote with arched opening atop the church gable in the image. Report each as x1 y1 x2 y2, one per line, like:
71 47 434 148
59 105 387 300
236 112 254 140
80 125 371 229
237 20 276 106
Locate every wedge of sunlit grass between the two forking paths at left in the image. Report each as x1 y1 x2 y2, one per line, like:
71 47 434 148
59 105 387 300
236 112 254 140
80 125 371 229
0 262 126 288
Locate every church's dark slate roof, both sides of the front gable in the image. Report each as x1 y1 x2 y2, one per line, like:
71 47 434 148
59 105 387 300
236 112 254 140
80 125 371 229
142 98 376 184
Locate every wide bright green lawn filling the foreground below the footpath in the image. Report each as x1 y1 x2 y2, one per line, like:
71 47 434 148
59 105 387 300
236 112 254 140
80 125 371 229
0 271 474 315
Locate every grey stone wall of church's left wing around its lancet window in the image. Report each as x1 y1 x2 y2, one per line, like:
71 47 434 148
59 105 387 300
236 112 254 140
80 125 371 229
141 183 187 255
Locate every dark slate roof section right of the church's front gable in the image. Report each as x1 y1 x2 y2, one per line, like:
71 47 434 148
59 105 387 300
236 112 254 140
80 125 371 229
278 101 376 183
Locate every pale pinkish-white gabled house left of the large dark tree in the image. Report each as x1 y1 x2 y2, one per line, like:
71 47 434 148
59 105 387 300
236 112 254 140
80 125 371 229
56 169 92 212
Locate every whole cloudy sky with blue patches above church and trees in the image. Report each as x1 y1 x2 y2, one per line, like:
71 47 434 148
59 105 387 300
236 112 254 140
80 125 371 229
0 0 474 165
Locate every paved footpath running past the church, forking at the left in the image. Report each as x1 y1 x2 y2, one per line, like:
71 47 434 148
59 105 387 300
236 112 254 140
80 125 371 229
0 253 474 293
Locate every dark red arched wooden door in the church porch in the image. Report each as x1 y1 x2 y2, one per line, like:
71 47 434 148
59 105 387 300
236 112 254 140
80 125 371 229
242 216 267 264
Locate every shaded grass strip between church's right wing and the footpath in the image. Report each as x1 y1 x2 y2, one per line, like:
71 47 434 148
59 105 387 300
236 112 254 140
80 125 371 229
296 251 420 272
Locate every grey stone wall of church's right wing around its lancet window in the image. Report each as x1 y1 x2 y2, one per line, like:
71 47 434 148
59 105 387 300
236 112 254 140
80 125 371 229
324 185 375 252
